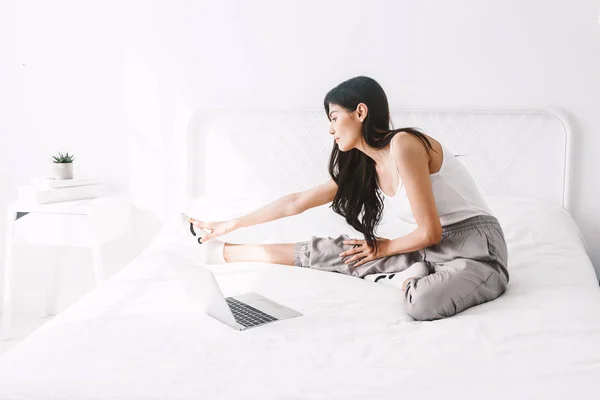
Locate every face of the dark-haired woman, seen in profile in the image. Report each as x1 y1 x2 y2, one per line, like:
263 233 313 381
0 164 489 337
329 103 366 151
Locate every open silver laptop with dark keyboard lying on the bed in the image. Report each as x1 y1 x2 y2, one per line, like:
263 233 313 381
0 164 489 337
170 252 302 331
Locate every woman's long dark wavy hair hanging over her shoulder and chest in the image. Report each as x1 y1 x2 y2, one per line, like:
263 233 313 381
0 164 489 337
323 76 435 255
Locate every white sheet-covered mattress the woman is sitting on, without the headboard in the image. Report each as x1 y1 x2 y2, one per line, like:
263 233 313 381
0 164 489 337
0 197 600 400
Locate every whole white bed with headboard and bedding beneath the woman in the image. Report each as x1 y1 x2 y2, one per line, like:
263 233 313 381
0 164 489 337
0 109 600 400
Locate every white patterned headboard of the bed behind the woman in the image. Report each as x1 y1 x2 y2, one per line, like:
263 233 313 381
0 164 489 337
187 109 571 211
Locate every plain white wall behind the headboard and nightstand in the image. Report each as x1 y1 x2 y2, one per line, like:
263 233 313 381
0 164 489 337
0 0 600 310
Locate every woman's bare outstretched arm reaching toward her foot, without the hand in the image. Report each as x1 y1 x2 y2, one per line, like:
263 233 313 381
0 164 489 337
235 180 337 228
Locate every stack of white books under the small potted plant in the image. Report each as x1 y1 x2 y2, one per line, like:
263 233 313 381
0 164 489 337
19 175 102 204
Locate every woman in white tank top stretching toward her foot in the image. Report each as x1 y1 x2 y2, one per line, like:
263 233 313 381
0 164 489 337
188 76 509 320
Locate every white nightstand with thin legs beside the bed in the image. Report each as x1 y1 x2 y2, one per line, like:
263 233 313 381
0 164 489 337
2 196 131 340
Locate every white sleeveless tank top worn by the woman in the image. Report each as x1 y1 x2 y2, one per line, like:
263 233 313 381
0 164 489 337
377 138 493 226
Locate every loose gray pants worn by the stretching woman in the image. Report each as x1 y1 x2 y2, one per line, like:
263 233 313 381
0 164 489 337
294 215 509 320
